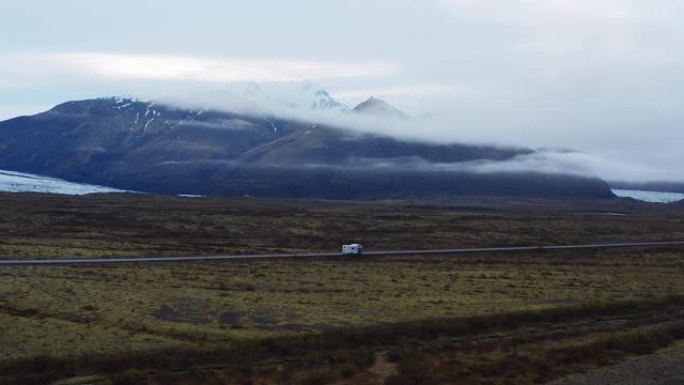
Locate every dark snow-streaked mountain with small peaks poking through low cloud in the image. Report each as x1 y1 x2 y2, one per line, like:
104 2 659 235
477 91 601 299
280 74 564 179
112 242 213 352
0 93 614 199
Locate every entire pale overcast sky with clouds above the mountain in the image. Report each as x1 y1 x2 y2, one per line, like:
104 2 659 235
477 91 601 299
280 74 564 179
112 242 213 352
0 0 684 180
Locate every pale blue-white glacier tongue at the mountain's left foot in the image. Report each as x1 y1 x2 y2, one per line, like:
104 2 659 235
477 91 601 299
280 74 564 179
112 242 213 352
0 170 126 195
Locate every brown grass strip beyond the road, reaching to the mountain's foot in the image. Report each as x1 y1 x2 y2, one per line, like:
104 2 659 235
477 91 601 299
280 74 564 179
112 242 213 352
0 194 684 259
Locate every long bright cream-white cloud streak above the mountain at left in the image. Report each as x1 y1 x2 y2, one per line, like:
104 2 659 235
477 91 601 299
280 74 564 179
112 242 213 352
0 52 398 92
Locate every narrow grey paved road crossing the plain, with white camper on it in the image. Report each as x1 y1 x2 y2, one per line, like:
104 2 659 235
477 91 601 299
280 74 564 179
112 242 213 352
0 241 684 266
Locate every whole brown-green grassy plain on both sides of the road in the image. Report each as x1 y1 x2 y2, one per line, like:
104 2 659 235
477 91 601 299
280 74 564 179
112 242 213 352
0 194 684 385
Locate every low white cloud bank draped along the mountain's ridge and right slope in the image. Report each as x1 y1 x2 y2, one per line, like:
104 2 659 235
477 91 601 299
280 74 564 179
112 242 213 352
152 82 684 182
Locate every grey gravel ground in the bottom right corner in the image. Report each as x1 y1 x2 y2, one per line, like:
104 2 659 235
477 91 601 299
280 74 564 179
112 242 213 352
546 343 684 385
